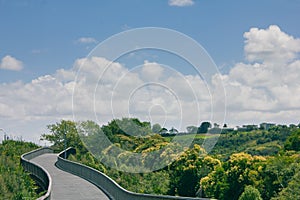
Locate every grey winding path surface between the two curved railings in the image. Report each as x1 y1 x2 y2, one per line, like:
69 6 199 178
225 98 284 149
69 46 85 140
31 154 109 200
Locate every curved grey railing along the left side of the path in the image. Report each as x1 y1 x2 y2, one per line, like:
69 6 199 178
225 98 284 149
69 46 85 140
20 147 53 200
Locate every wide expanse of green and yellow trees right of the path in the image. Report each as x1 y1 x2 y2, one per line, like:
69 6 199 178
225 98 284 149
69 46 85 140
42 118 300 200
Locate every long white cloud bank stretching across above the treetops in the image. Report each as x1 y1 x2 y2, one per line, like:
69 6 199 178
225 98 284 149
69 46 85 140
0 25 300 142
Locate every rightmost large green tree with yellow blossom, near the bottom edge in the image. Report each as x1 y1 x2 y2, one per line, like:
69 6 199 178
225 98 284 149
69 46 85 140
200 152 265 200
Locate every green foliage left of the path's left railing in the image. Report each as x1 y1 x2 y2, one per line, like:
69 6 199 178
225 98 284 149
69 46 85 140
0 140 38 200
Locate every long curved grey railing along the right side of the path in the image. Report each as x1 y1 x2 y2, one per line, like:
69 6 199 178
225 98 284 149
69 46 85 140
56 147 211 200
